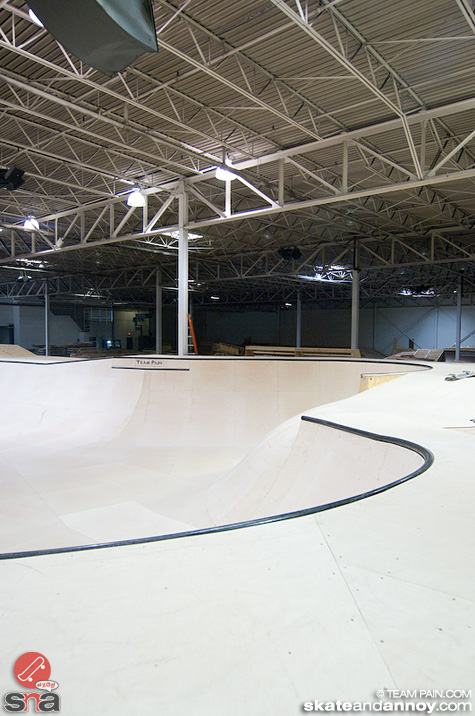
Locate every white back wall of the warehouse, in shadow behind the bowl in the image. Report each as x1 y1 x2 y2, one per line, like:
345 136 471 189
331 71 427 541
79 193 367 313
6 304 475 355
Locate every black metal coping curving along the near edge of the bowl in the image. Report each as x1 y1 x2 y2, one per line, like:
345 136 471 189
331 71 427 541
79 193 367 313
0 415 434 560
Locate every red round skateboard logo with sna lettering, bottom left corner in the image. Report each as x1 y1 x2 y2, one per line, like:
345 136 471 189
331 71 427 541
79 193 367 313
3 651 61 713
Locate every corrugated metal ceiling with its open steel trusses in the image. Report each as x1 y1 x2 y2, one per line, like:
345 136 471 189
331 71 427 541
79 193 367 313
0 0 475 302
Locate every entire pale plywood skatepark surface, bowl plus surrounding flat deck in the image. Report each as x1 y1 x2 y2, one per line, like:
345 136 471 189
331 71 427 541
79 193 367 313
0 356 475 714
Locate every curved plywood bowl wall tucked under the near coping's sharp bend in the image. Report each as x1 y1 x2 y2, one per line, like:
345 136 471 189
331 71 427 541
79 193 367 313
208 418 424 525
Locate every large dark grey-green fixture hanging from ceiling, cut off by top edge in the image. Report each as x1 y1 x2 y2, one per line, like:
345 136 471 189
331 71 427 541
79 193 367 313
28 0 158 75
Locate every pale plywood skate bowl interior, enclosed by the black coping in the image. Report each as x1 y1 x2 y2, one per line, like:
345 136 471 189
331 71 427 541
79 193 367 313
0 357 431 554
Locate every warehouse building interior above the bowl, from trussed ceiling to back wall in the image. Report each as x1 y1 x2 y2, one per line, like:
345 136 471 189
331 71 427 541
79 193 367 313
0 0 475 355
